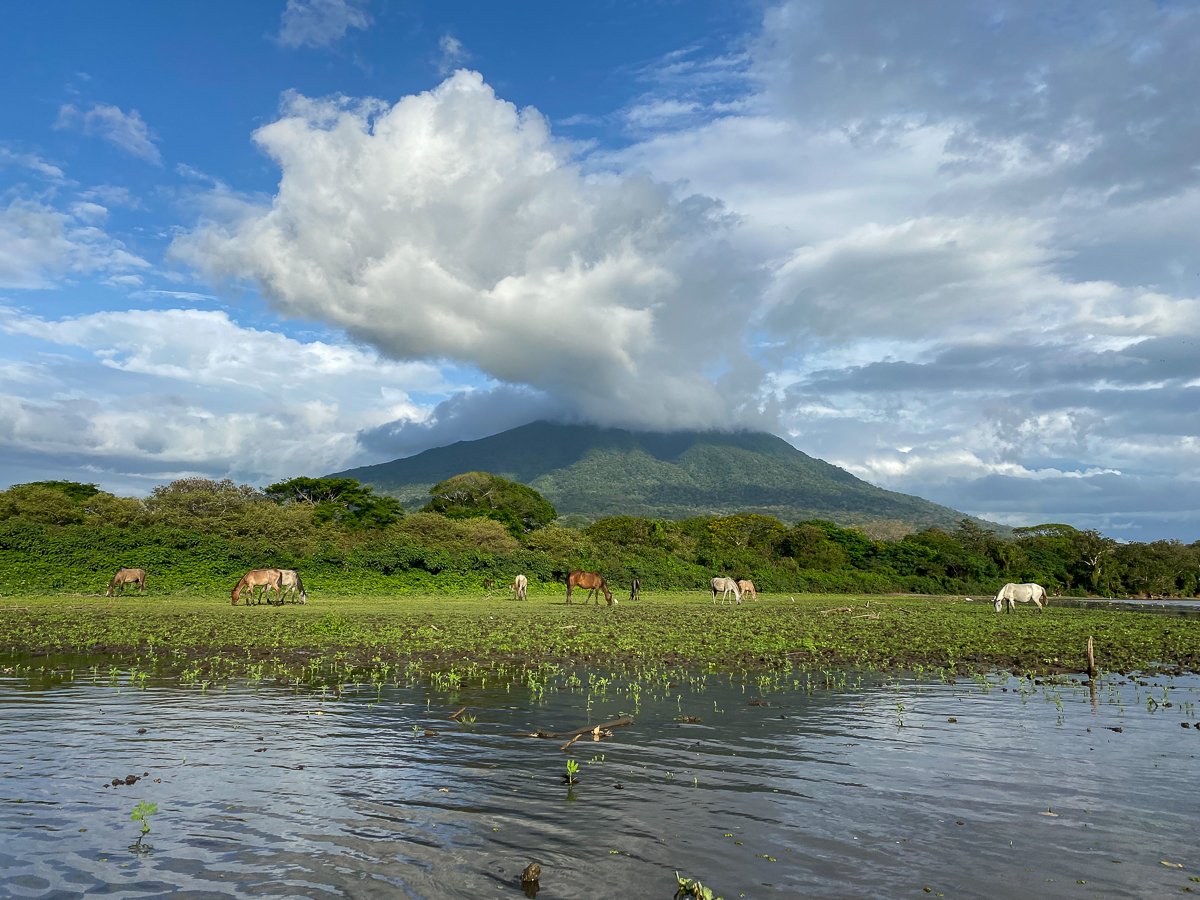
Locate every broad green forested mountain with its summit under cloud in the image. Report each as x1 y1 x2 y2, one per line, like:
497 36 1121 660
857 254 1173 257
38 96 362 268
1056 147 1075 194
334 421 996 536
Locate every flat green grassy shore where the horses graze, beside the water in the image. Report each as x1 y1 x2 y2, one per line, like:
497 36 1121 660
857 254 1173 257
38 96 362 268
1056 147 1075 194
0 593 1200 677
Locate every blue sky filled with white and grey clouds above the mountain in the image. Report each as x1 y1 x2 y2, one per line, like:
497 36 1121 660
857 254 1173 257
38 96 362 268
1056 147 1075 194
0 0 1200 542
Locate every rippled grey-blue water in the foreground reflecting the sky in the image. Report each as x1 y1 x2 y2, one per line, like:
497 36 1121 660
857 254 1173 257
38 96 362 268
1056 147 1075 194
0 670 1200 900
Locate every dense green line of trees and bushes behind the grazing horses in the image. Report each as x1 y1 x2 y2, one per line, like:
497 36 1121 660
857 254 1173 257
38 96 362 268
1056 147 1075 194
0 472 1200 598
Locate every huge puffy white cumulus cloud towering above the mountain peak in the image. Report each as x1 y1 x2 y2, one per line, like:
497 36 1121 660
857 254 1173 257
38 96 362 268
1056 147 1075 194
175 71 755 427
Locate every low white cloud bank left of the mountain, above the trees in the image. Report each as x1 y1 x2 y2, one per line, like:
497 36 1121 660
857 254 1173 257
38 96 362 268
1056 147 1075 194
0 308 456 494
